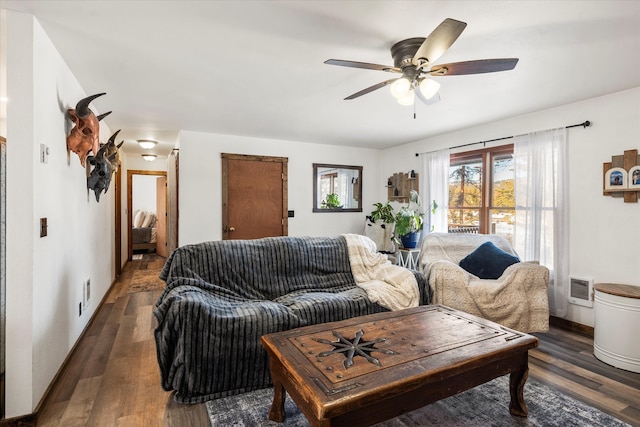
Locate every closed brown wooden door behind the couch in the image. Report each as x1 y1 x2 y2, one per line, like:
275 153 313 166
222 153 288 240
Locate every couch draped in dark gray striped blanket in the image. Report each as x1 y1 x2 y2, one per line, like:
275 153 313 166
154 236 431 403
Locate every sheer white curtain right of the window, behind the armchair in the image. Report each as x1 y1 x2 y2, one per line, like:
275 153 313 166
513 128 569 317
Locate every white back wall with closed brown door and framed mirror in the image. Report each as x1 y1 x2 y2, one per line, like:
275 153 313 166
179 131 382 245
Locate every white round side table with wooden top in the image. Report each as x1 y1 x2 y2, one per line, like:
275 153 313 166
593 283 640 373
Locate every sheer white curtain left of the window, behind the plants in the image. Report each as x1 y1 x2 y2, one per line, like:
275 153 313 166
420 149 449 233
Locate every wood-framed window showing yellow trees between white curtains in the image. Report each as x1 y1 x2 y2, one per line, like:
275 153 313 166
448 145 515 241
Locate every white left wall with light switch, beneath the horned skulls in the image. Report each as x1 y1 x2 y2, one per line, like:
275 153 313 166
6 11 115 417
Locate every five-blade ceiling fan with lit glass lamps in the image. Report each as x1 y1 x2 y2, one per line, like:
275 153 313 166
324 18 518 105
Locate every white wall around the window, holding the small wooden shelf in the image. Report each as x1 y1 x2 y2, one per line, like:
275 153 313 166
382 88 640 326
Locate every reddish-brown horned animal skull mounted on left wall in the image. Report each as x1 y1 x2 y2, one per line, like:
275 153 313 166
67 93 111 167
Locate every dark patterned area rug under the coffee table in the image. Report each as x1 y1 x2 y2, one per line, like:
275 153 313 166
206 376 628 427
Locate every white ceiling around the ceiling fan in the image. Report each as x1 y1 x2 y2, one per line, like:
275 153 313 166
0 0 640 157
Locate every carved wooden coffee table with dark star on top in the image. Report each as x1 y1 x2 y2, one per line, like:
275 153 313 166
262 305 538 426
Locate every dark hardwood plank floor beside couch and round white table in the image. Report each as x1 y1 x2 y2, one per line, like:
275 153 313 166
22 255 640 427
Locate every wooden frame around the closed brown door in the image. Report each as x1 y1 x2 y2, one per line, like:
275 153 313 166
220 153 289 240
